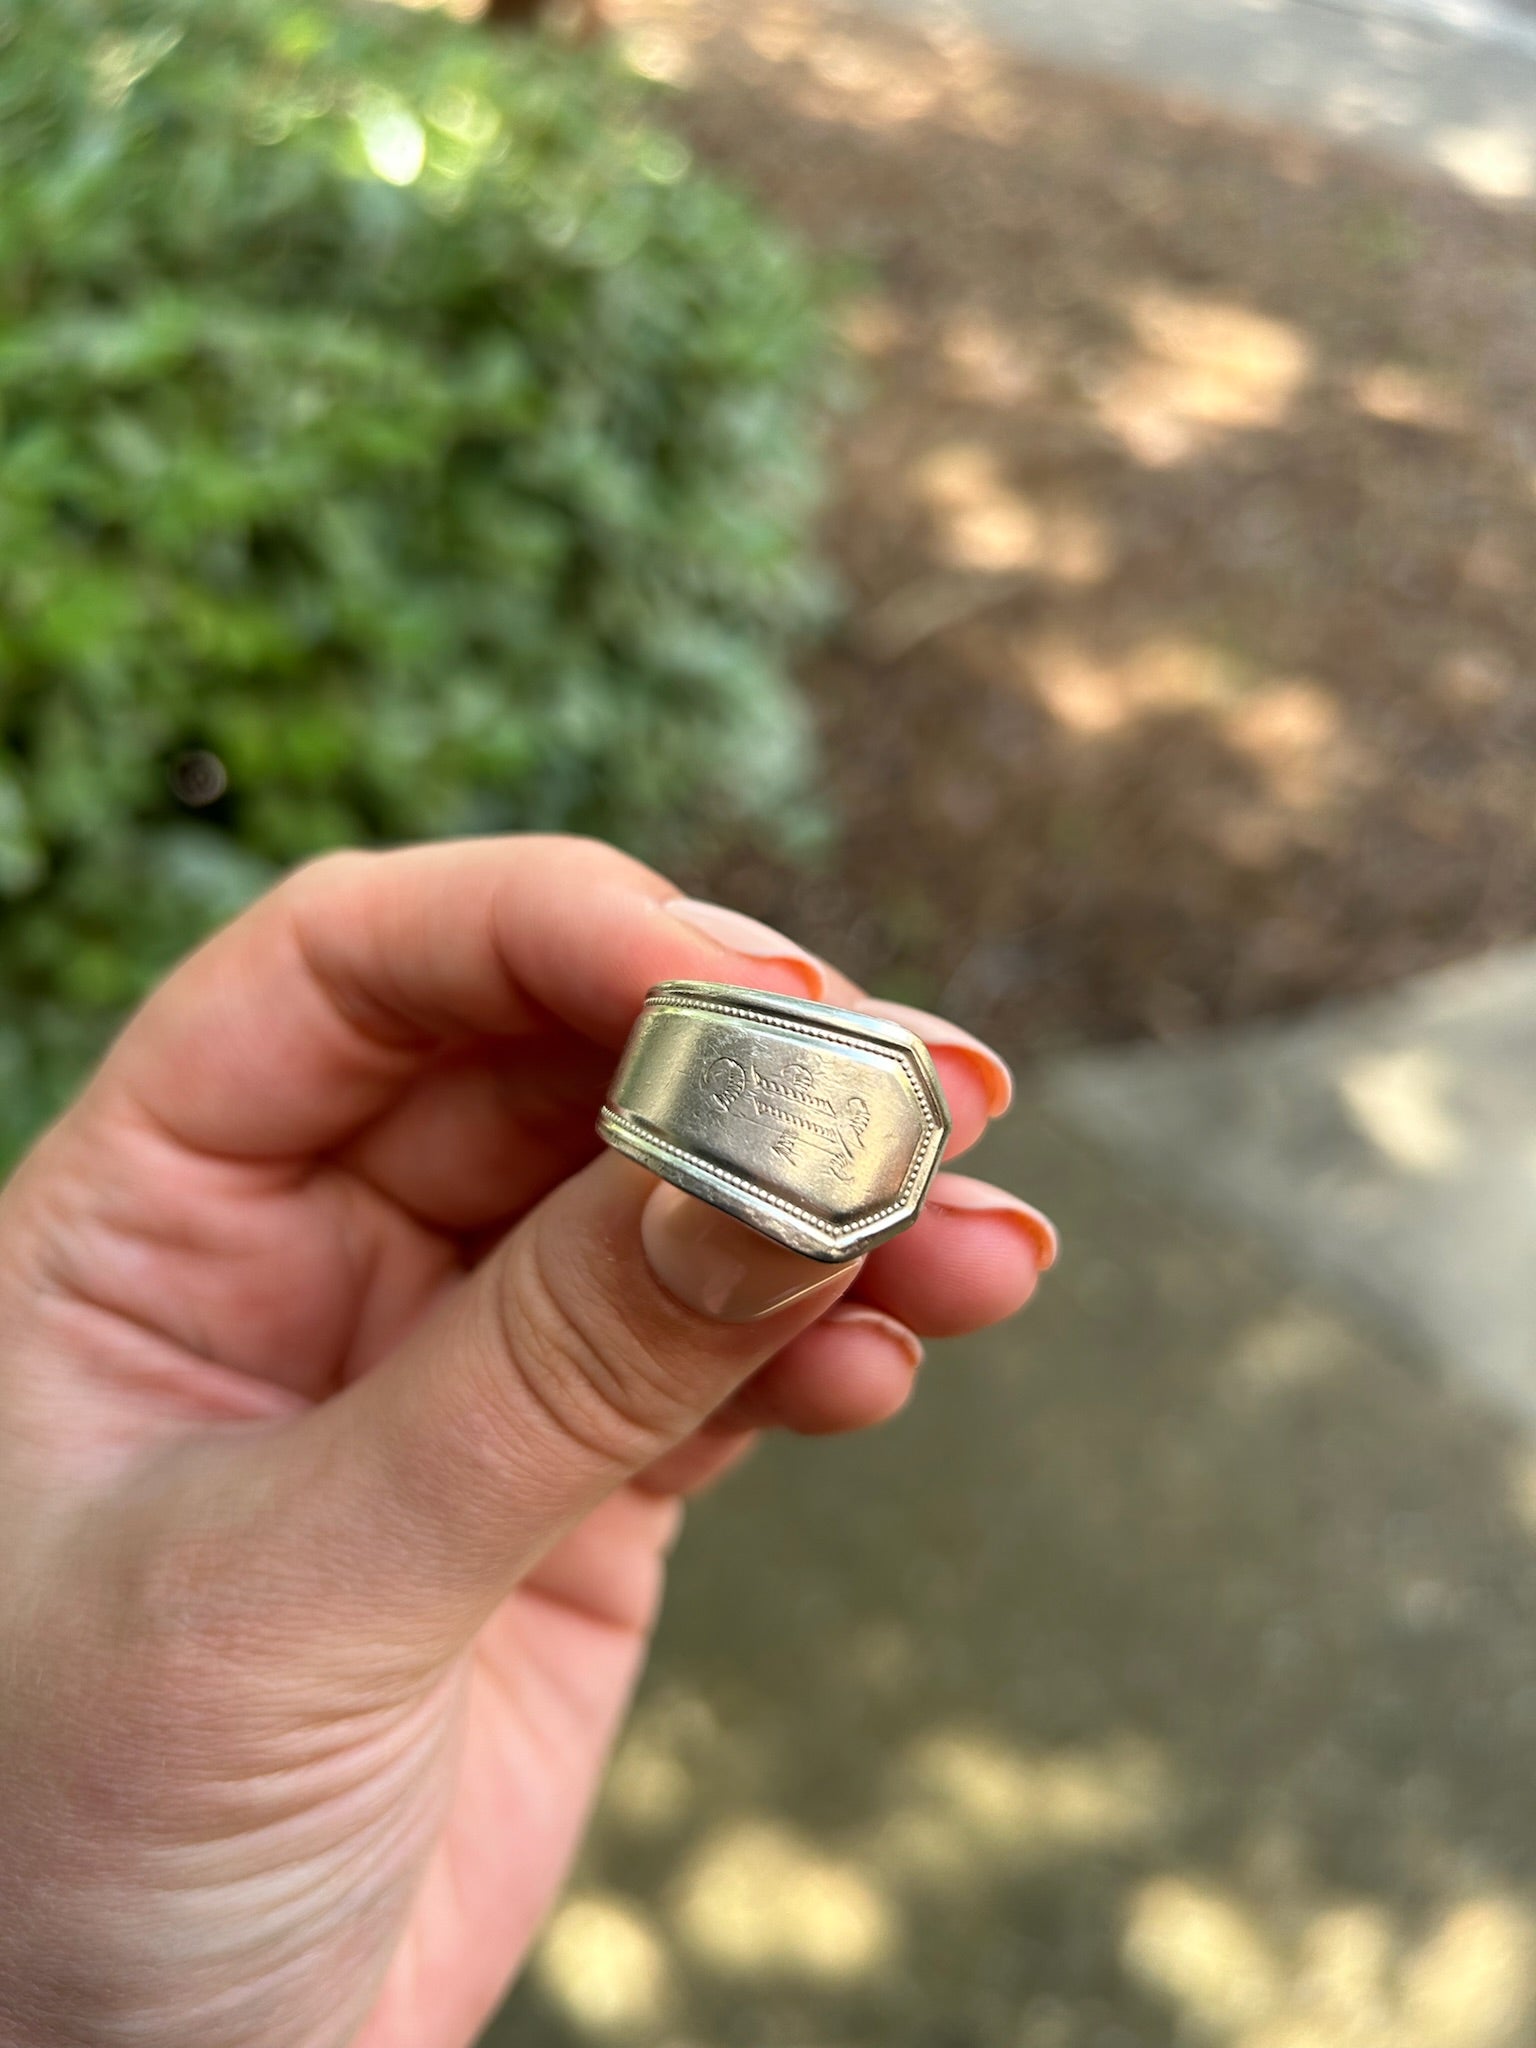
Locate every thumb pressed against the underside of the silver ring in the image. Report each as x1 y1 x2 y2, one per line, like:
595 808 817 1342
272 1153 858 1655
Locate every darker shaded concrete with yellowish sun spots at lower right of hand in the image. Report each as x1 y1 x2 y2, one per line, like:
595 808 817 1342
489 1110 1536 2048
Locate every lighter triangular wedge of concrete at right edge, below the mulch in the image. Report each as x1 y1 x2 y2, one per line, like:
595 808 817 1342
1047 946 1536 1421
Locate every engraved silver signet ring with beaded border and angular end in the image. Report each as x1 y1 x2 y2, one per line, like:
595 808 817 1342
598 981 950 1264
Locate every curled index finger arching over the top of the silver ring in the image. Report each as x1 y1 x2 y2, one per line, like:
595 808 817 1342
90 836 827 1159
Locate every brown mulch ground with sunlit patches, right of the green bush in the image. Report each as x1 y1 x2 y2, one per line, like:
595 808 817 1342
612 0 1536 1055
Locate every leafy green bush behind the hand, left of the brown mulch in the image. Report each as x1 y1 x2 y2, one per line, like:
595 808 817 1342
0 0 843 1157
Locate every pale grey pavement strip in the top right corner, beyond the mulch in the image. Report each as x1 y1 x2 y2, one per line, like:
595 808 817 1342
883 0 1536 201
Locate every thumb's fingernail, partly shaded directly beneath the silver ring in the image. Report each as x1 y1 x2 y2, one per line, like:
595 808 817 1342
641 1182 858 1323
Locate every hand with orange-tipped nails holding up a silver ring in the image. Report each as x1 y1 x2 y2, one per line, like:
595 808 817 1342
0 838 1049 2048
